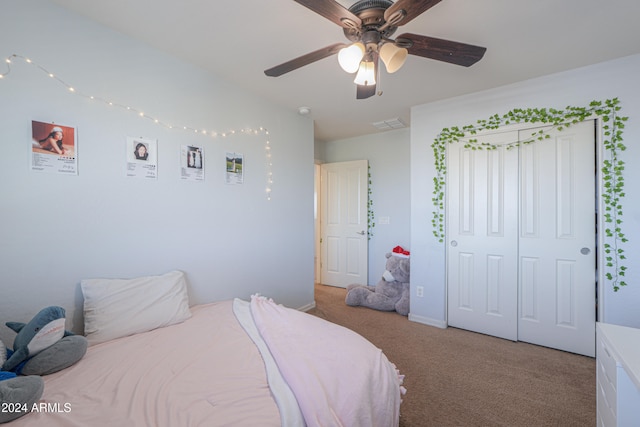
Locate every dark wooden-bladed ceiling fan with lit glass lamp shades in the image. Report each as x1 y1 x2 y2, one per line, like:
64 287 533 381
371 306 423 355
264 0 487 99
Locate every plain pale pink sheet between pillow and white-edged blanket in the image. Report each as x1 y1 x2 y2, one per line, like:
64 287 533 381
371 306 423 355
7 301 281 427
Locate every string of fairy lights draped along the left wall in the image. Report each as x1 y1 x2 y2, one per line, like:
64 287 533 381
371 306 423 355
0 54 273 200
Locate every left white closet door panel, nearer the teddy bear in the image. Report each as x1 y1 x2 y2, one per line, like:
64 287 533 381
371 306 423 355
447 132 518 340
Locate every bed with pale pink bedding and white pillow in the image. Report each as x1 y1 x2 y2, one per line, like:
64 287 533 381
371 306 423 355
8 271 404 427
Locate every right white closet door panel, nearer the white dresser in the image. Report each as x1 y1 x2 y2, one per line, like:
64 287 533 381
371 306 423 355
518 121 596 356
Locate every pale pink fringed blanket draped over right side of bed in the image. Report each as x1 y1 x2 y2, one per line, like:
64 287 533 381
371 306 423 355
251 296 404 427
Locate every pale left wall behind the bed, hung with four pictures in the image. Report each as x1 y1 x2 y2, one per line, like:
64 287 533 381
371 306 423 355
0 0 314 345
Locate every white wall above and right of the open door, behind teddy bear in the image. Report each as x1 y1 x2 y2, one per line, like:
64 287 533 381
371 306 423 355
324 129 411 285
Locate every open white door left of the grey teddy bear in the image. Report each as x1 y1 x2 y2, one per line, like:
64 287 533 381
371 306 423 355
320 160 369 287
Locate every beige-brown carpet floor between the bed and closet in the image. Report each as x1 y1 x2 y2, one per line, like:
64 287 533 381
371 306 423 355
309 285 596 427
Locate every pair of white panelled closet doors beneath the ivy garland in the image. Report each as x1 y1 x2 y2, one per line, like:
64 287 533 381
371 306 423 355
447 121 596 356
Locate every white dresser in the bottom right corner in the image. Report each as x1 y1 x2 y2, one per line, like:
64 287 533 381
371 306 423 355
596 323 640 427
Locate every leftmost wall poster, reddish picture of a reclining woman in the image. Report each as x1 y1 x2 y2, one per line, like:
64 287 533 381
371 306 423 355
31 120 78 175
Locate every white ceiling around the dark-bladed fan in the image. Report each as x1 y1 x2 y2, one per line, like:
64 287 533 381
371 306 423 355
52 0 640 141
